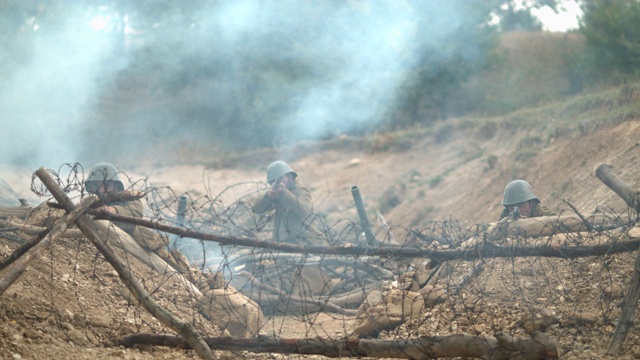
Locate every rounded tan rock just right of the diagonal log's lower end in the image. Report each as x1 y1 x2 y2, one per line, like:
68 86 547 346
198 286 264 338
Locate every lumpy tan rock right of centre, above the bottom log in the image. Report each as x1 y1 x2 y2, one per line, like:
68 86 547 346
351 289 424 337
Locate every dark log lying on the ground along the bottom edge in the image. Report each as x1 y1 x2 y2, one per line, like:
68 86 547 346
118 333 558 359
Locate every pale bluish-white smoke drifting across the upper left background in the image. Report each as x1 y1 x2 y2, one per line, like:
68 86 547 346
0 0 478 168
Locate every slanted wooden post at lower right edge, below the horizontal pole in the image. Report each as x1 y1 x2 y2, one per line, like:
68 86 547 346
607 243 640 355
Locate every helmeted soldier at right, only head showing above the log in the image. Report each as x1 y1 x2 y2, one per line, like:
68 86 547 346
500 180 555 220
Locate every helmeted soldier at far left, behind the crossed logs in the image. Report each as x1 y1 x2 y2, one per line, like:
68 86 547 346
84 162 189 271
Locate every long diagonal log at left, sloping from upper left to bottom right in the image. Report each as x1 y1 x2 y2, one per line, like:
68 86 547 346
36 167 214 359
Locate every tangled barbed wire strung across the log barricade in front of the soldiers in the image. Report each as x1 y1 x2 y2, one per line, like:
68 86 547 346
0 164 640 358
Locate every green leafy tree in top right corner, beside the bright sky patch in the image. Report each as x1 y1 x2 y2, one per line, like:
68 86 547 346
580 0 640 77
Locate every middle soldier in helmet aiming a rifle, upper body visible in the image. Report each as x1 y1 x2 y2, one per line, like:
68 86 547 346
252 160 320 244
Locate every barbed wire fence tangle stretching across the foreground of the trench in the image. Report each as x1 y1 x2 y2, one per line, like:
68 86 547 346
0 164 640 358
